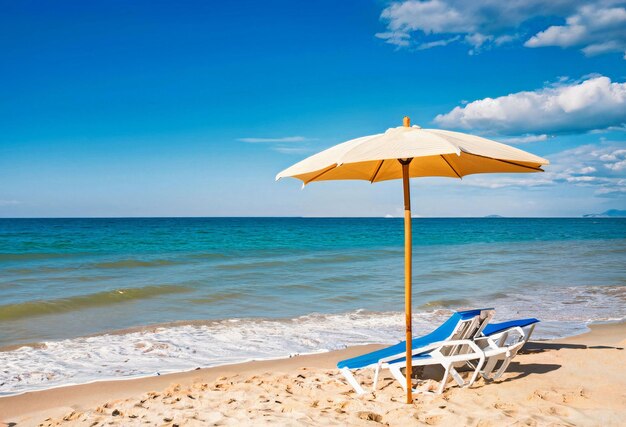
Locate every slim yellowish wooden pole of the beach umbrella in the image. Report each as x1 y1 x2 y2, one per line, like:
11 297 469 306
400 159 413 403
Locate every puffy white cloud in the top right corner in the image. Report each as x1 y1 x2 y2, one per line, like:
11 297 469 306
524 5 626 56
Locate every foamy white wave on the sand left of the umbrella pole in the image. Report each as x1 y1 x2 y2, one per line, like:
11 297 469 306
0 311 412 395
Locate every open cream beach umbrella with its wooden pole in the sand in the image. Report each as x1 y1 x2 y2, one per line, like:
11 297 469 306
276 117 549 403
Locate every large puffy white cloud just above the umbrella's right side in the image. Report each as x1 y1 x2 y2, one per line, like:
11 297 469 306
434 76 626 135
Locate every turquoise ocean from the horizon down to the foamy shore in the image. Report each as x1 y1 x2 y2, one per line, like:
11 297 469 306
0 218 626 395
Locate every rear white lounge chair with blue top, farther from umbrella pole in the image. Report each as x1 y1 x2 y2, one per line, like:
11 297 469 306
469 318 539 380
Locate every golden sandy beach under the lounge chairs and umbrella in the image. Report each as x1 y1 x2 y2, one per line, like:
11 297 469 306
0 324 626 426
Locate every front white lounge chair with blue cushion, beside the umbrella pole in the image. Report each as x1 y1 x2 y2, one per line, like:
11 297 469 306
337 309 493 394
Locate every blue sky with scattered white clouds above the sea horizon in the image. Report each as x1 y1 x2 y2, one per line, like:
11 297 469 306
0 0 626 217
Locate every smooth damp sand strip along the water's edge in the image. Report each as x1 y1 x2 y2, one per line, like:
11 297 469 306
0 322 626 425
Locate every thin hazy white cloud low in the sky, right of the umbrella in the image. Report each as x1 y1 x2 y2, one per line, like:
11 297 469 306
465 141 626 197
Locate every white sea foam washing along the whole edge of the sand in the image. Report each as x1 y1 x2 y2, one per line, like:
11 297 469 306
0 286 626 395
